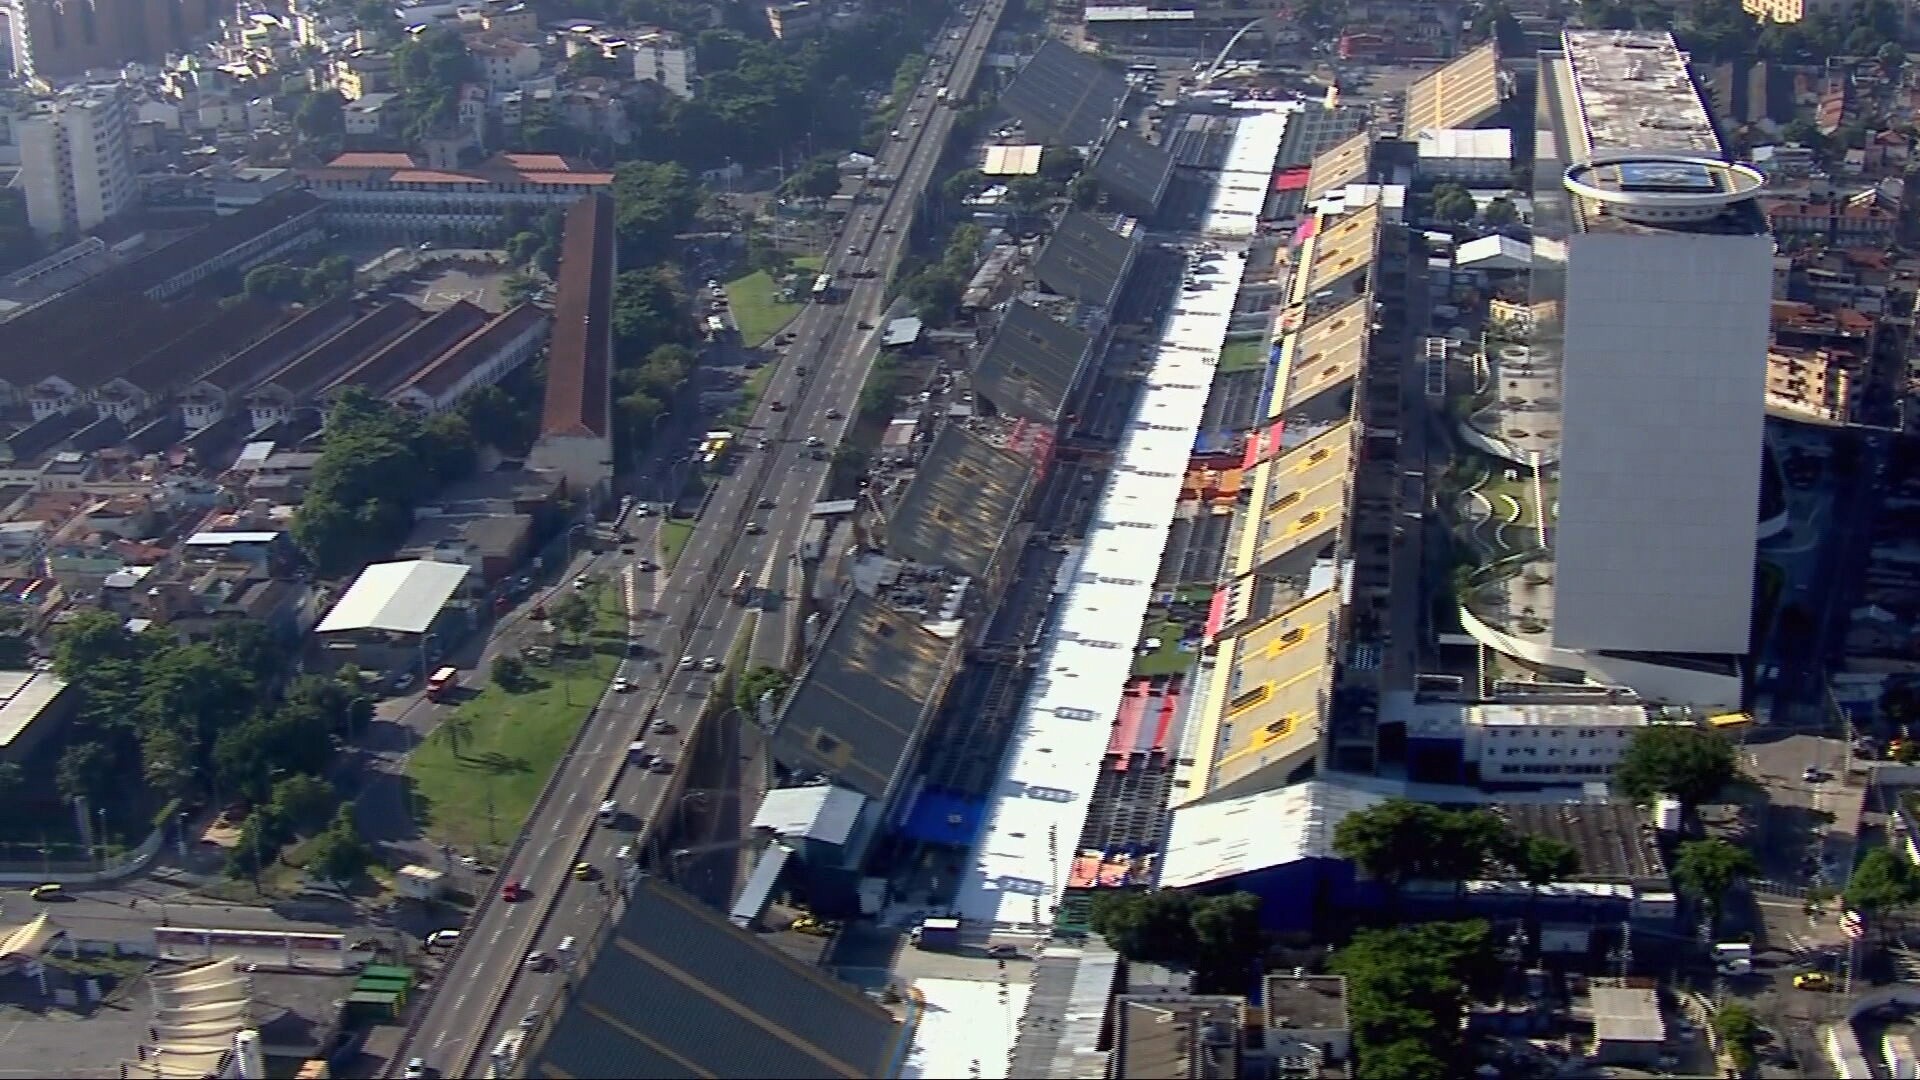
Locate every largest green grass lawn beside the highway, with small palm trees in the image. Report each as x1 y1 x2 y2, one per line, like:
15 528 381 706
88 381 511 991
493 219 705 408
407 588 626 849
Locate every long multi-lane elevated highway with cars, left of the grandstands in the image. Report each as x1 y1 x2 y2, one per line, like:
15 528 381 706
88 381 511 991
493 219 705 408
390 0 1004 1076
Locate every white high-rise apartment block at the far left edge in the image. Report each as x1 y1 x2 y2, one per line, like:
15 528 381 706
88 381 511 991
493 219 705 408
15 85 140 236
